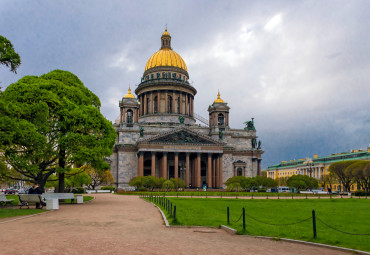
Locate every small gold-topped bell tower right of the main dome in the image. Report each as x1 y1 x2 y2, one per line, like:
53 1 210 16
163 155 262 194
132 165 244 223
208 91 230 131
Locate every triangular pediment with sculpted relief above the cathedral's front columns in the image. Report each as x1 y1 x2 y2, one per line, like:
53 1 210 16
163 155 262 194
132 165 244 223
139 128 221 145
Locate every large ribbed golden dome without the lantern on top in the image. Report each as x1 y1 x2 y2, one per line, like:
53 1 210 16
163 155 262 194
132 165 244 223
145 48 188 71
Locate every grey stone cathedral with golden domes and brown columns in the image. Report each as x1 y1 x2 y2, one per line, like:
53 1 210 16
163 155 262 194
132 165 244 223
110 29 263 190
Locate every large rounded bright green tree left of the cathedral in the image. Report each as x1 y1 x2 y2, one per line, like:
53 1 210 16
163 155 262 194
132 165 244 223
0 70 116 192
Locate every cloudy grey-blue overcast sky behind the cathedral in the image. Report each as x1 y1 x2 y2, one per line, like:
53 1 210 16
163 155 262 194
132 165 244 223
0 0 370 168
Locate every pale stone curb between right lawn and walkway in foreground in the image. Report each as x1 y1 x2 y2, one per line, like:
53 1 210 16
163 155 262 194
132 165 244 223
221 225 370 255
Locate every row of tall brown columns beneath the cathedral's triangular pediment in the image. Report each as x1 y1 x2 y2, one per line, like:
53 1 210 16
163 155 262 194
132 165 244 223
138 151 223 188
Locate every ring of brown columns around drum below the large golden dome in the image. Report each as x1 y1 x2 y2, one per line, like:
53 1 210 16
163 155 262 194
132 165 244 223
138 90 194 116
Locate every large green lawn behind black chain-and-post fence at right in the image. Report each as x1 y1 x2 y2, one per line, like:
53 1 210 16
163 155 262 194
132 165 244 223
145 197 370 251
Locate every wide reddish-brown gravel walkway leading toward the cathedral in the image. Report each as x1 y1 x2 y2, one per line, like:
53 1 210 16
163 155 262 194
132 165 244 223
0 194 349 255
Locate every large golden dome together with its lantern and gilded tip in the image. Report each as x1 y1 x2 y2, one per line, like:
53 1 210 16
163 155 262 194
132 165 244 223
145 28 188 71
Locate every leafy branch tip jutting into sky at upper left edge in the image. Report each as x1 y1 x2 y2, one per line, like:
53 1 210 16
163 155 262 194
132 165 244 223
0 35 21 73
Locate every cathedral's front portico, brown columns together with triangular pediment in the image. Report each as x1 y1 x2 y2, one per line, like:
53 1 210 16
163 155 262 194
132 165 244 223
137 128 223 188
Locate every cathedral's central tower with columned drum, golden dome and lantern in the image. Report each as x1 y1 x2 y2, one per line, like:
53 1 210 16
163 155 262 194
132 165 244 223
135 29 197 125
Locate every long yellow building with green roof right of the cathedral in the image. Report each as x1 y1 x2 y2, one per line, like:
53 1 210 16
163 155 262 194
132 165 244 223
266 147 370 191
